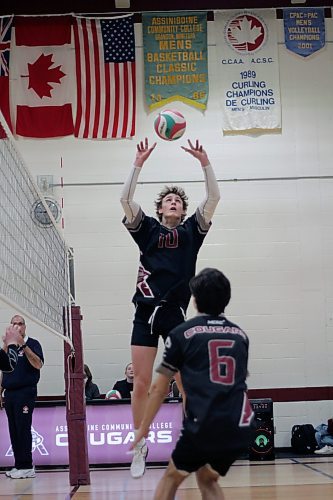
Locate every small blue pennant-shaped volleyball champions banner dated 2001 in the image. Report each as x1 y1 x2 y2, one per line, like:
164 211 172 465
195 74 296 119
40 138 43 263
283 7 325 57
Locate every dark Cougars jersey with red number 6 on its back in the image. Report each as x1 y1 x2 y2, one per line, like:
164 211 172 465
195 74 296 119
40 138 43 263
157 315 253 449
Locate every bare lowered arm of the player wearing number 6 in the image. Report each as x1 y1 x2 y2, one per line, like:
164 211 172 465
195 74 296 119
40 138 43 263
130 374 171 450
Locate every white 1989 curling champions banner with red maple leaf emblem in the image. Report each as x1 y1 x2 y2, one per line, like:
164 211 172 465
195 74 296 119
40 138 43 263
215 9 281 134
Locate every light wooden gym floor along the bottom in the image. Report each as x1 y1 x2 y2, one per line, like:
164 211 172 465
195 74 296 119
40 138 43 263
0 455 333 500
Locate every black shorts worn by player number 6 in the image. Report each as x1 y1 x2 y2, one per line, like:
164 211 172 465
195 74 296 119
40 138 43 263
171 430 239 476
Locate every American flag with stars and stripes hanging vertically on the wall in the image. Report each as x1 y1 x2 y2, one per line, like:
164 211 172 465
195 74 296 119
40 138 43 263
74 15 136 139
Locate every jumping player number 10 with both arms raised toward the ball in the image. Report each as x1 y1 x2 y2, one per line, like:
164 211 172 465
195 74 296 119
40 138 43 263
121 138 220 478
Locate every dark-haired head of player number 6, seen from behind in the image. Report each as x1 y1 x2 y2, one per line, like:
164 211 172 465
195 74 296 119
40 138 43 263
190 267 231 315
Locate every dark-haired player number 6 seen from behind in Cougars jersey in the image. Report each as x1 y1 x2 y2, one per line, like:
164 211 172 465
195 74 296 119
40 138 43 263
132 268 254 500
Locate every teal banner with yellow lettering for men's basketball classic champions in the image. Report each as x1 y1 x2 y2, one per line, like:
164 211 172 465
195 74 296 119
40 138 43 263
142 12 208 110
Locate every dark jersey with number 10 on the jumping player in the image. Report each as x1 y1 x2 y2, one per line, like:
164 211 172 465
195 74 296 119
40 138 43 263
123 209 211 310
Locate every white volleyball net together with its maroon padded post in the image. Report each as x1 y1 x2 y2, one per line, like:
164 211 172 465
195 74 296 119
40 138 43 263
0 113 90 485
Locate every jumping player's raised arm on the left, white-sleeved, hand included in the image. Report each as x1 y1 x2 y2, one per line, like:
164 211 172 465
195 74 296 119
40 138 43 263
120 138 156 222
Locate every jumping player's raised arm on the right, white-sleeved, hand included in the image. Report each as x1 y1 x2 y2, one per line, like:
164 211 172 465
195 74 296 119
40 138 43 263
182 139 220 224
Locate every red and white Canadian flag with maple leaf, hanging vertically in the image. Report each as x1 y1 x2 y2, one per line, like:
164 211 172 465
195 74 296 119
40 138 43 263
9 16 75 138
